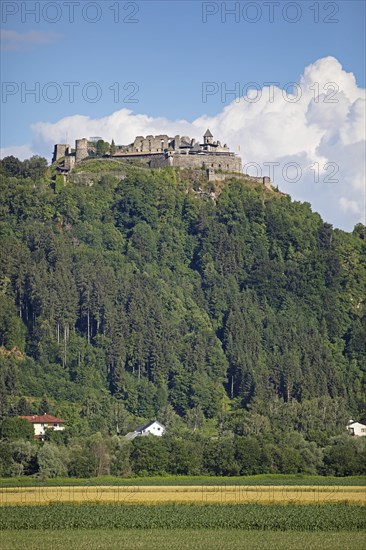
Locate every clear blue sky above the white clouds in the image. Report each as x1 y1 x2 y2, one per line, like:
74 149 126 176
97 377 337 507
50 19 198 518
0 0 365 230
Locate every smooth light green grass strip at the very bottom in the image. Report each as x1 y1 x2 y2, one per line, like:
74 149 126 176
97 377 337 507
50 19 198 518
0 529 365 550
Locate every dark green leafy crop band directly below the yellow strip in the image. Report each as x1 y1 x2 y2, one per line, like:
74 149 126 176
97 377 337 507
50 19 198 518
0 504 366 532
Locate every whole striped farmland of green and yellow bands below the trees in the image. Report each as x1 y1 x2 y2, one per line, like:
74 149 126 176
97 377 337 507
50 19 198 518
0 475 366 550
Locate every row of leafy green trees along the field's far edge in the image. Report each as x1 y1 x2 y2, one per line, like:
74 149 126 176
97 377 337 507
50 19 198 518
0 420 366 479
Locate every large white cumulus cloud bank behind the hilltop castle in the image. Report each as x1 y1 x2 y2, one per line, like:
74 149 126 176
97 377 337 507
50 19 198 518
3 57 365 230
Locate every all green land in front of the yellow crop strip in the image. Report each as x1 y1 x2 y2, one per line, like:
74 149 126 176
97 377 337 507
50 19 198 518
0 503 366 550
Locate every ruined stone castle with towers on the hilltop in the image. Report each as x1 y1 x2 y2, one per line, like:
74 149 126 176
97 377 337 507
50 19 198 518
52 130 242 180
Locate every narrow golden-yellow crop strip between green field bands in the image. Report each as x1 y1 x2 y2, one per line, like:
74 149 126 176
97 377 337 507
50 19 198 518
0 485 366 506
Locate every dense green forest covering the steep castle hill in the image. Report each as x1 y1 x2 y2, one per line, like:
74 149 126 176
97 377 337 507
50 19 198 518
0 157 366 475
